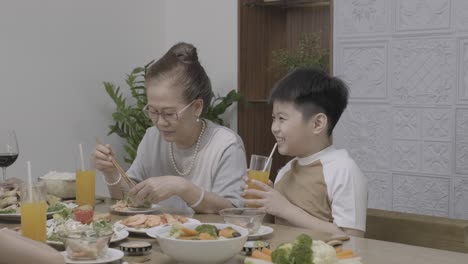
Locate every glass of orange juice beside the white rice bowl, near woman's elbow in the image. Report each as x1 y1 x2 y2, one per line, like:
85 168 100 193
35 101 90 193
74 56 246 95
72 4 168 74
76 149 96 206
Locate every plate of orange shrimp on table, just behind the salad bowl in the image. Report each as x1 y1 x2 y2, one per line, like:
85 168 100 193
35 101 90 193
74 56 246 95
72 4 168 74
114 214 200 234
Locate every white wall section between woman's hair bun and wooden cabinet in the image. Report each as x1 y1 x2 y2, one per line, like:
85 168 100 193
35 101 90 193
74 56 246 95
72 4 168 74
164 0 238 131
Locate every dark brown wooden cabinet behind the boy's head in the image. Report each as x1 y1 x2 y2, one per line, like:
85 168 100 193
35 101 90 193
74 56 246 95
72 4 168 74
238 0 333 180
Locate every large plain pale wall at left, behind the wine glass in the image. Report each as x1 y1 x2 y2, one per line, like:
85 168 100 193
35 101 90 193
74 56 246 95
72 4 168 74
0 0 164 194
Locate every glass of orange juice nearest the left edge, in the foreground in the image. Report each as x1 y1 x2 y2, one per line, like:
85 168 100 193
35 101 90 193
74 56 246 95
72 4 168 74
20 182 47 242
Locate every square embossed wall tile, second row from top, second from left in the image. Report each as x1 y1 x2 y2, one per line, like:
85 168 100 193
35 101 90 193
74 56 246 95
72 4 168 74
391 39 456 105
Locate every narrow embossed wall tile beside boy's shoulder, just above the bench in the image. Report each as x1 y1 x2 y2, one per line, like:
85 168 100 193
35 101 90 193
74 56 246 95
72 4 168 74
365 172 393 210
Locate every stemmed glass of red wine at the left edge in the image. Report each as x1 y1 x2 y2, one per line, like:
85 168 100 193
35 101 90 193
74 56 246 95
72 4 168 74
0 129 19 182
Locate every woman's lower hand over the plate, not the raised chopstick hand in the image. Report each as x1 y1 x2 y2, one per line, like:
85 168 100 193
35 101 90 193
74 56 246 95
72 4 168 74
128 176 187 203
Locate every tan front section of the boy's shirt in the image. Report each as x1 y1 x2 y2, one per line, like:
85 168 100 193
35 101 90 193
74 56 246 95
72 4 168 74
275 160 333 225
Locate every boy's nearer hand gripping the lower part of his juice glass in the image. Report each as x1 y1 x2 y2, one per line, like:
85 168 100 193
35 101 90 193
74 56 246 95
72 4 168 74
242 180 292 218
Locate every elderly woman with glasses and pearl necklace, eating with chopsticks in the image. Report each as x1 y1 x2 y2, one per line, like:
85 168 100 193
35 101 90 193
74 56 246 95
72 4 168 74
93 43 246 213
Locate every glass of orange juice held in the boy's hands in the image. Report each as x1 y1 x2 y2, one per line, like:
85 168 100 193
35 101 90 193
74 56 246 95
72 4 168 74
245 155 272 205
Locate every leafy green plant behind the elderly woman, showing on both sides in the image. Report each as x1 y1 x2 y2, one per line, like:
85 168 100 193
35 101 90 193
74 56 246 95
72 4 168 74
104 61 242 164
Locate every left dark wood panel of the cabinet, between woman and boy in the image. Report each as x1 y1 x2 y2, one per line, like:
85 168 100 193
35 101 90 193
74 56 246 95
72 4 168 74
238 0 286 177
